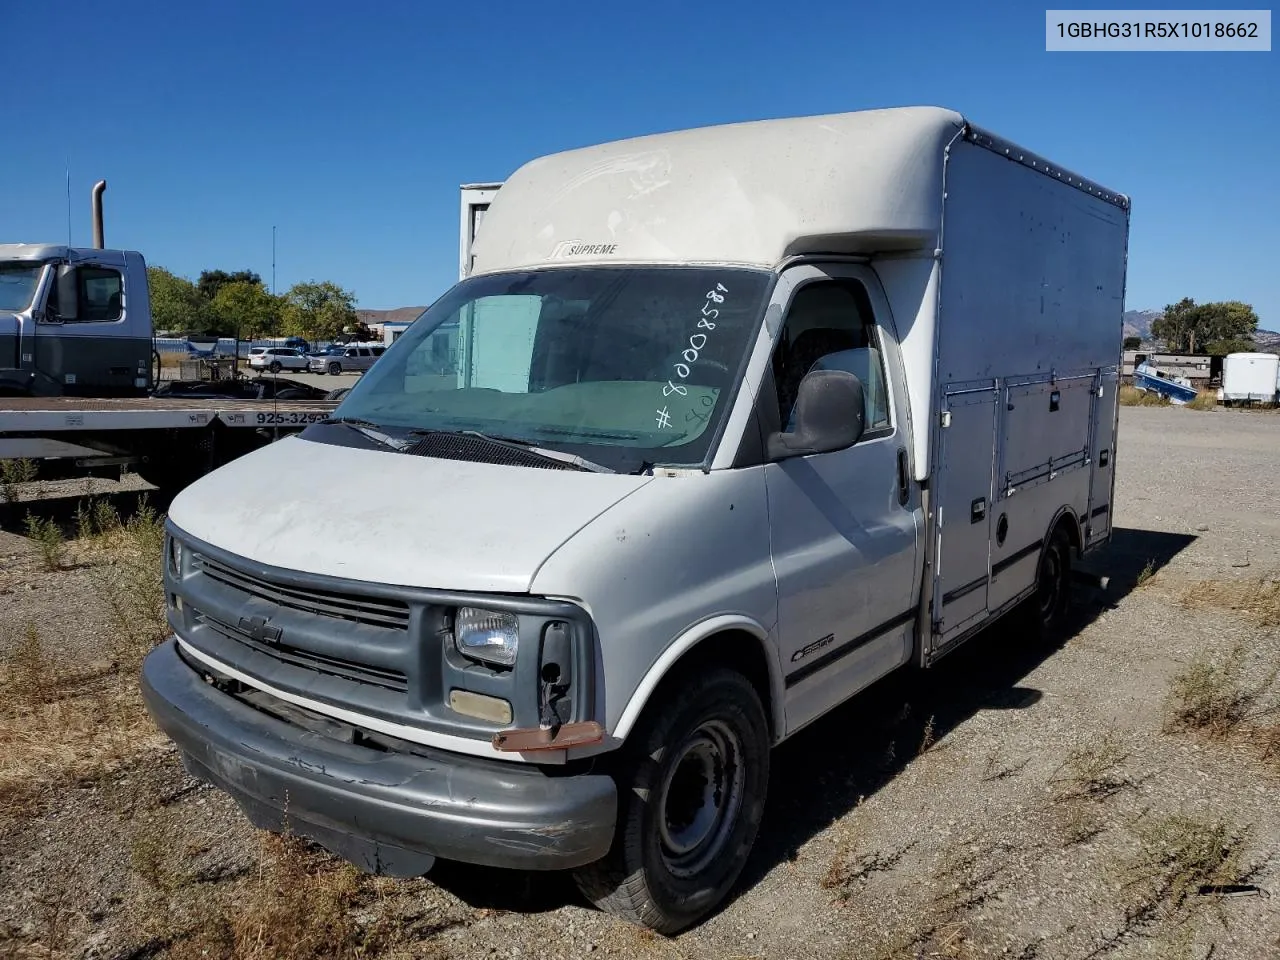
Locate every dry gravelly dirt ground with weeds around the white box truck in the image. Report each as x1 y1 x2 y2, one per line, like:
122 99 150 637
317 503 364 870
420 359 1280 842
0 407 1280 960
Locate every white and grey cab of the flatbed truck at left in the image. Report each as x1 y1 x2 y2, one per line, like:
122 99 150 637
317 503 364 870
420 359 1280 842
0 243 154 397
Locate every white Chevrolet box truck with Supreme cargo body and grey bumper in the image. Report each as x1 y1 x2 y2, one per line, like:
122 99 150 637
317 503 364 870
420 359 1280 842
142 108 1129 933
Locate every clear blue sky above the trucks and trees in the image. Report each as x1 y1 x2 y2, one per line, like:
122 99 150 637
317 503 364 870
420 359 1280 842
0 0 1280 329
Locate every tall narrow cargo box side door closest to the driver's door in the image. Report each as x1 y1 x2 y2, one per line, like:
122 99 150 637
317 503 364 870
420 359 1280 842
931 380 1000 652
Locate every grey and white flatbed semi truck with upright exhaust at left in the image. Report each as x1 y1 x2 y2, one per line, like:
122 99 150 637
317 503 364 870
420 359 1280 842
0 180 334 493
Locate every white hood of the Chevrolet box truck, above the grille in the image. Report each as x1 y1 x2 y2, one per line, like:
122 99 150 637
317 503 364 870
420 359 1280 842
169 436 652 593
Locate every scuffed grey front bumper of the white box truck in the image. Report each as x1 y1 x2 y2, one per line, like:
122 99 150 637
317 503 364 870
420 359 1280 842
142 639 617 876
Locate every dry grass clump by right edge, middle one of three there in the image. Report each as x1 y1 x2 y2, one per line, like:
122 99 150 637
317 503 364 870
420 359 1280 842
1166 645 1276 737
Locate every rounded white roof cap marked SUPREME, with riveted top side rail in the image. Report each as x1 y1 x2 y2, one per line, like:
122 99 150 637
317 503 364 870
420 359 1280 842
472 106 1115 273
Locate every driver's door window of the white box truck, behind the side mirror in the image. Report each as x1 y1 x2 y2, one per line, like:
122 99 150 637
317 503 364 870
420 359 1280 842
773 279 890 434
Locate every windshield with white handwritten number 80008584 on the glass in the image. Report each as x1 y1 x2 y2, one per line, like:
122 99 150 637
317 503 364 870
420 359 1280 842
334 268 772 468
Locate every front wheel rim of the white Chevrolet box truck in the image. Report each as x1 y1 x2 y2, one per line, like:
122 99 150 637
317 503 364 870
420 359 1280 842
658 721 745 876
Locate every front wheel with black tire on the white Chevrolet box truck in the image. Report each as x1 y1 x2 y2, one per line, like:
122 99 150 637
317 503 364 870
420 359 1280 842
573 668 769 936
